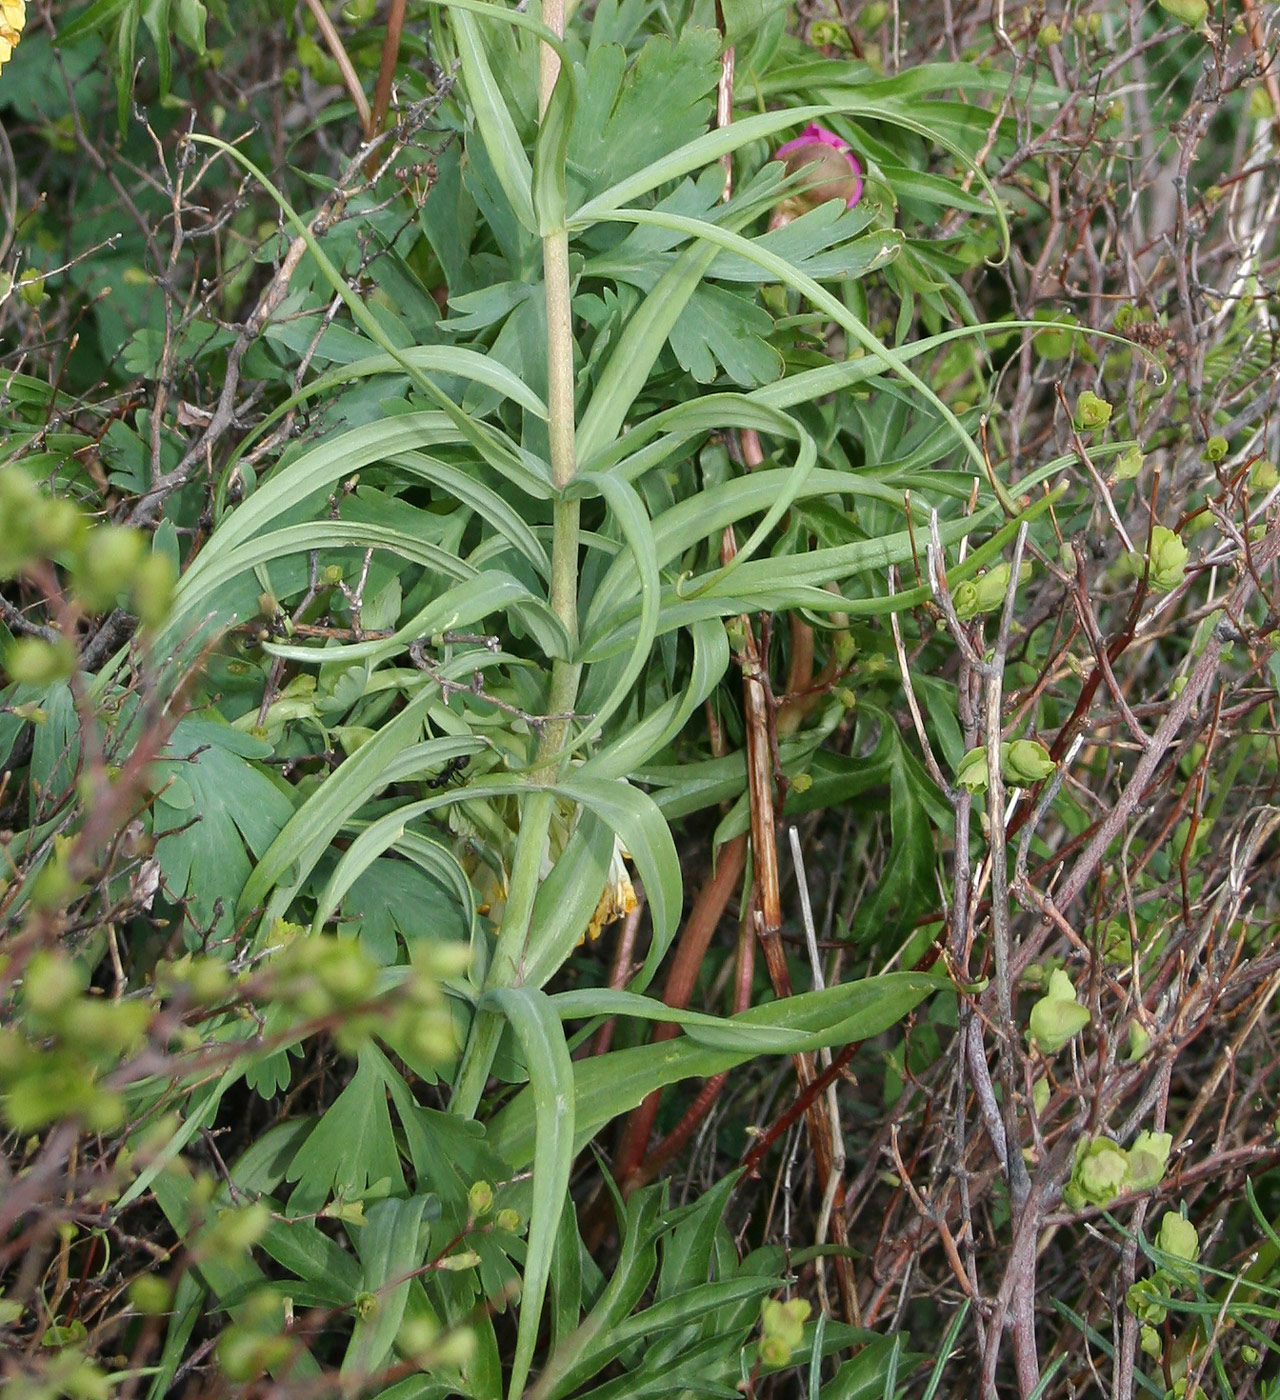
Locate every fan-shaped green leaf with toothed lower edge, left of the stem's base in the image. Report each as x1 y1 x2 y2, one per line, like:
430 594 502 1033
286 1050 405 1215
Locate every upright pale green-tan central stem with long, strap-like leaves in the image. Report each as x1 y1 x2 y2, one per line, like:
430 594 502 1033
452 0 581 1117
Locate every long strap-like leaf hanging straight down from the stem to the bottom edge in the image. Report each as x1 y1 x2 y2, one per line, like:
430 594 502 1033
483 987 574 1400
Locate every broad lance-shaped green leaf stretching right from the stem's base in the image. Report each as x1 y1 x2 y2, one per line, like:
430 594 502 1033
489 973 945 1169
